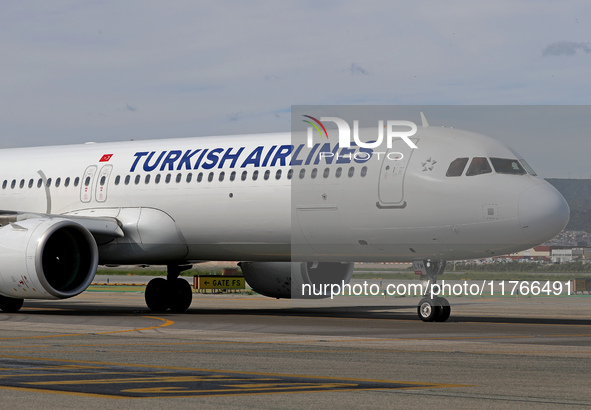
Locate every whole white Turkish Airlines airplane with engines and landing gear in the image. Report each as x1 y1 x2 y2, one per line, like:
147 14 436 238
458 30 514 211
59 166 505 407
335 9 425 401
0 113 570 322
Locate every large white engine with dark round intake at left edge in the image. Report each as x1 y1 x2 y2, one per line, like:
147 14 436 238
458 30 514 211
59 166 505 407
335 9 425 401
0 218 98 299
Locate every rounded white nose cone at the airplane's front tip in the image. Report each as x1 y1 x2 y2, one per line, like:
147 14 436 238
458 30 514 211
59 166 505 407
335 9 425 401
519 183 570 243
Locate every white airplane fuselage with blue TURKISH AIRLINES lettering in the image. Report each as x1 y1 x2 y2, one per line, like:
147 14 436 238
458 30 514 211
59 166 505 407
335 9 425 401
0 127 569 264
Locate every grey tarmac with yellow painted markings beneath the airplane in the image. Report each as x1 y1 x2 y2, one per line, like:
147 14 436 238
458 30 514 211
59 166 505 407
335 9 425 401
0 277 591 409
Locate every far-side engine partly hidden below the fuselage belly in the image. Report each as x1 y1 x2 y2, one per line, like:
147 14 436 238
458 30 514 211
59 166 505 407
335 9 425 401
239 262 354 299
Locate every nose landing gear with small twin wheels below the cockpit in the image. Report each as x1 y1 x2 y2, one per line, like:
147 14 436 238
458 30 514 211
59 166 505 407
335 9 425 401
413 260 451 322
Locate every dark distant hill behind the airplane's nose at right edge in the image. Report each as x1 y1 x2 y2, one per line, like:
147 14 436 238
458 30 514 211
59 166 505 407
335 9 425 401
546 178 591 233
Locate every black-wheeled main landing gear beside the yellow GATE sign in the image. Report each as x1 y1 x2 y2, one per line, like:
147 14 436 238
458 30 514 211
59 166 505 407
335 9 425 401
145 265 193 313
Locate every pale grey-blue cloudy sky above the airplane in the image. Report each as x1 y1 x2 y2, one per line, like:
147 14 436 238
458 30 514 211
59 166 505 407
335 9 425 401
0 0 591 178
